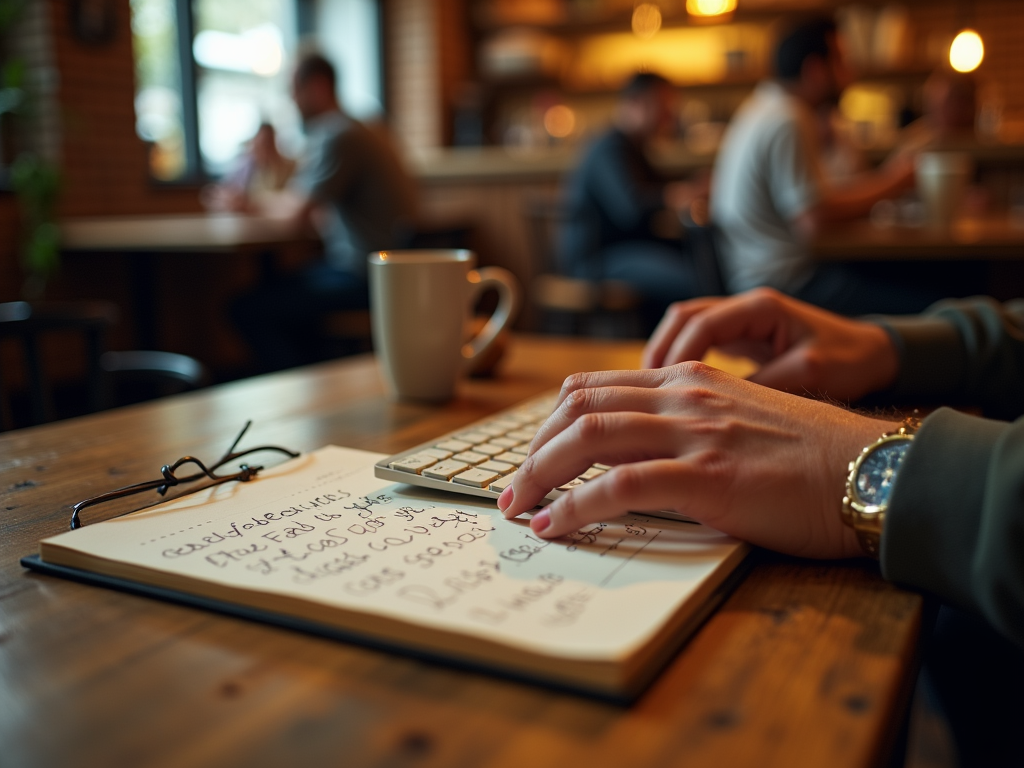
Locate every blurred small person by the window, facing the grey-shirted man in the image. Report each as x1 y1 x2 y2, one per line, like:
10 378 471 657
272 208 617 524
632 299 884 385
203 123 295 212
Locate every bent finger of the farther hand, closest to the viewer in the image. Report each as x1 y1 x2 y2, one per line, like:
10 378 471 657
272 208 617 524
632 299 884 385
665 291 790 366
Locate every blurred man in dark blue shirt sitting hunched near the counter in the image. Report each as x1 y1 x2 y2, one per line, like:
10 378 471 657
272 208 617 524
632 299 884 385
558 73 696 333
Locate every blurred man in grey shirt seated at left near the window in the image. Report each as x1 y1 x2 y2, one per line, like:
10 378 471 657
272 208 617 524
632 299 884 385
231 54 417 371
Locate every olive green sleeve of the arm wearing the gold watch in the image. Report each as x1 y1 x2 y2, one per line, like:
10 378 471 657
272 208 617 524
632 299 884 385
880 409 1024 646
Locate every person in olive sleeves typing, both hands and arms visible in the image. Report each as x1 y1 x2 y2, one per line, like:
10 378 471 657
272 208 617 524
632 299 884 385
498 289 1024 765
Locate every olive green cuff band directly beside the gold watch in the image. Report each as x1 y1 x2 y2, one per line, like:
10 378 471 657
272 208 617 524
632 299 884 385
880 409 1009 610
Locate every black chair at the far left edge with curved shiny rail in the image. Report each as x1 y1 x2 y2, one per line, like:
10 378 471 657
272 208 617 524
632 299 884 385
0 301 207 429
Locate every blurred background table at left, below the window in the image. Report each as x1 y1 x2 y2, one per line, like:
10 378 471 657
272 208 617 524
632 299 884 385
60 213 316 351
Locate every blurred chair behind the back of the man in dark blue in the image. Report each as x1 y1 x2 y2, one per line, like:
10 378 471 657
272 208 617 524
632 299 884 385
523 196 640 336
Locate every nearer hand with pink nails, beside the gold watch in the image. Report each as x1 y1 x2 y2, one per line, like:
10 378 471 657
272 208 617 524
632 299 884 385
498 362 894 558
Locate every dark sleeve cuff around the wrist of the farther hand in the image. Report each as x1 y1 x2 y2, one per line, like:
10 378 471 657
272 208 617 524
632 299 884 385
868 315 967 401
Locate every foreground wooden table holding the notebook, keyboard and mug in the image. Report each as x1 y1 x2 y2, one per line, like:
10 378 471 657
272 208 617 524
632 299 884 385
0 338 923 768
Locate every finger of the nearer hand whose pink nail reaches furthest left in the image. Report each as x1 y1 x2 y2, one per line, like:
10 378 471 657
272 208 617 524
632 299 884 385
500 413 680 517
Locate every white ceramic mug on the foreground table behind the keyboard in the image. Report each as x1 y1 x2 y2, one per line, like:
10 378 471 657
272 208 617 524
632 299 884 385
369 250 519 402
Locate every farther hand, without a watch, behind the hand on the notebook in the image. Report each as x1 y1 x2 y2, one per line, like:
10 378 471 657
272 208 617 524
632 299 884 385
643 288 899 401
